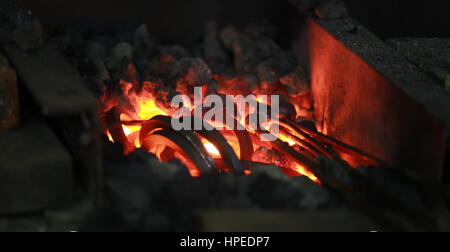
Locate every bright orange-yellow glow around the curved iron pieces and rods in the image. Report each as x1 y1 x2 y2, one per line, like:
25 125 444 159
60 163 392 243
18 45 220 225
101 69 384 183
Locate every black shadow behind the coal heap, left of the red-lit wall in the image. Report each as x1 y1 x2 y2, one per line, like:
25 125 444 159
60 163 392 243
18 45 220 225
25 0 293 44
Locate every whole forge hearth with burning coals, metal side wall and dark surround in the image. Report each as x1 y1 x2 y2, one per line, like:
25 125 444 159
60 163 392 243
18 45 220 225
0 0 450 231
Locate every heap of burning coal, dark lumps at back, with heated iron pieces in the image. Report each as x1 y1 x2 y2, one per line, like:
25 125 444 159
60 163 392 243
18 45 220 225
97 22 384 183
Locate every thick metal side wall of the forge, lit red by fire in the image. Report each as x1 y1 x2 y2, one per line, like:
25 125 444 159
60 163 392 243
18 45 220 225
293 13 450 184
